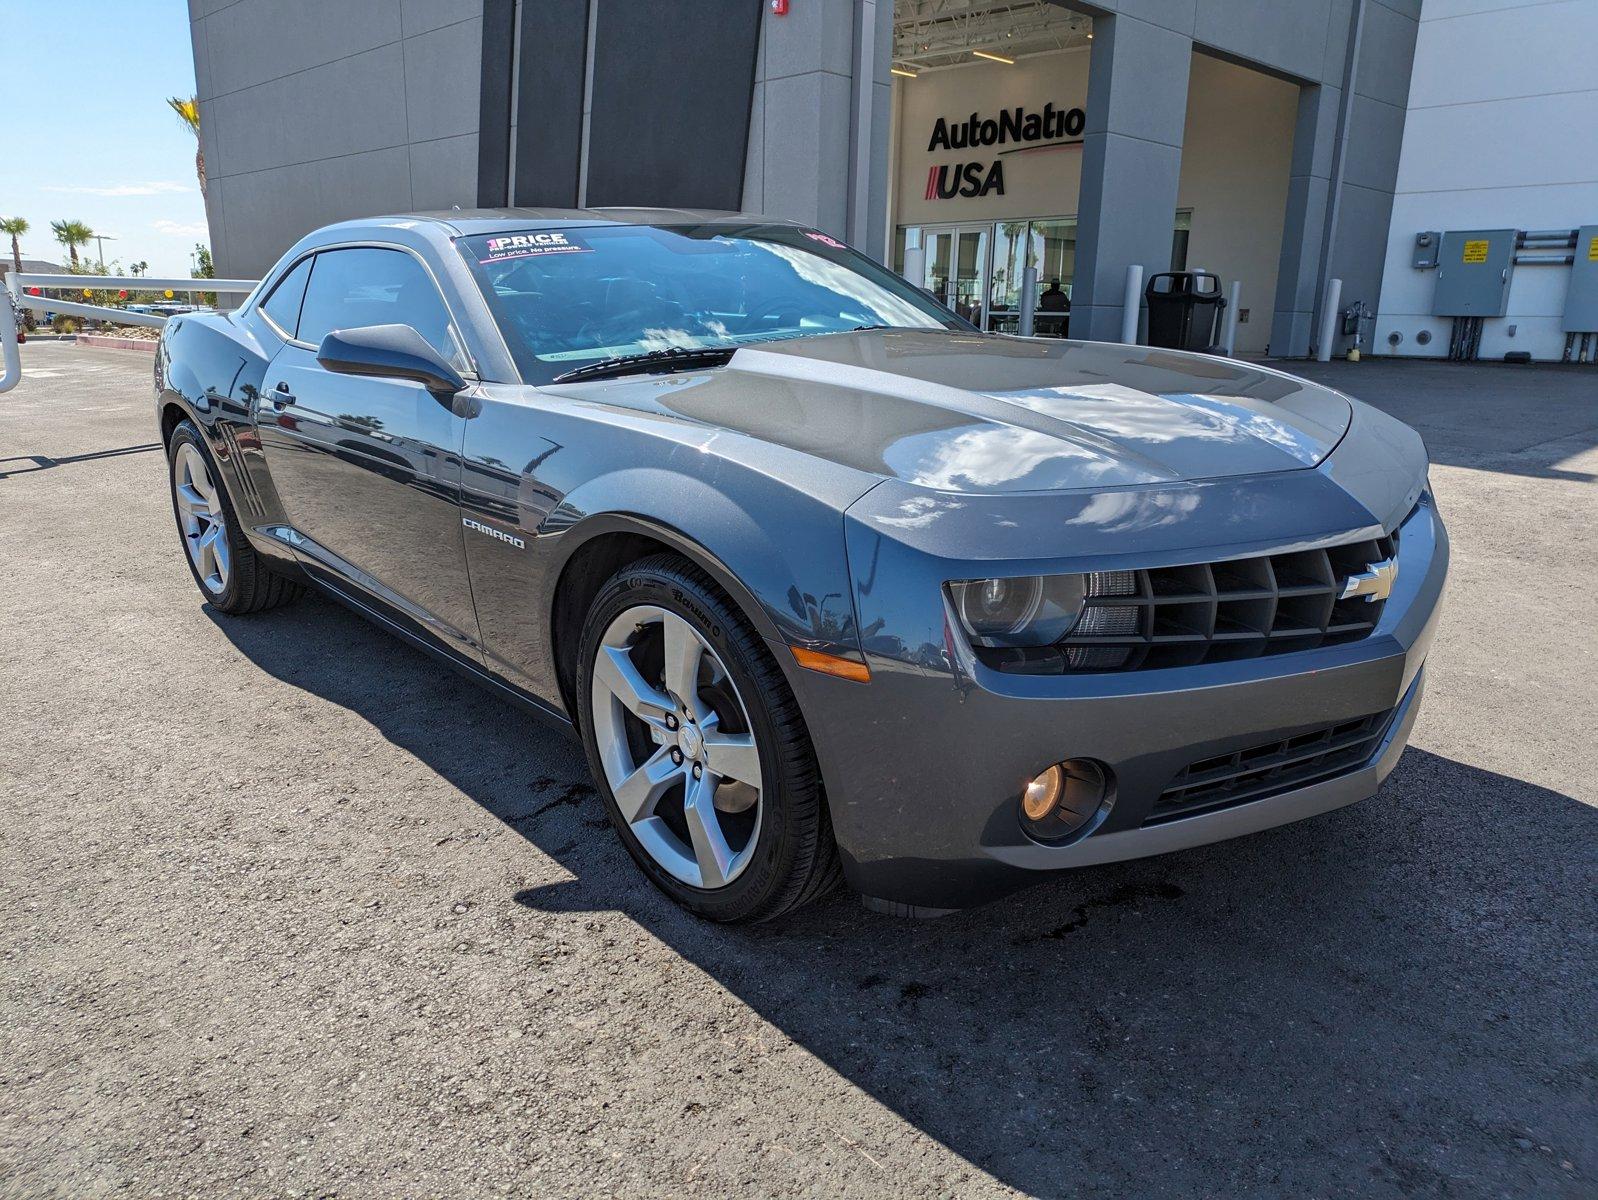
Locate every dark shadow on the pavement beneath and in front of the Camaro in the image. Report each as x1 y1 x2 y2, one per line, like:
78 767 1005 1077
206 599 1598 1197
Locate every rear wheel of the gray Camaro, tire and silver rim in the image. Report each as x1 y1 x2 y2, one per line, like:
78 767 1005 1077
166 420 302 614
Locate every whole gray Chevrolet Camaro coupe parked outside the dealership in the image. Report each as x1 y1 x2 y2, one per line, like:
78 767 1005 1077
155 209 1448 920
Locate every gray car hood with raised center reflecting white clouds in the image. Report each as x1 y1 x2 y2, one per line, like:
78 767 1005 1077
546 329 1352 494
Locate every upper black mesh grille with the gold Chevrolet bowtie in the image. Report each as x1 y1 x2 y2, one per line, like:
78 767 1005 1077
984 530 1398 674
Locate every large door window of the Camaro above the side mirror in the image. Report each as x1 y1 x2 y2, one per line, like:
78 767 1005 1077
297 246 465 368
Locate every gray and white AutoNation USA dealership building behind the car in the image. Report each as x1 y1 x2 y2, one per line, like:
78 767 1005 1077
190 0 1598 358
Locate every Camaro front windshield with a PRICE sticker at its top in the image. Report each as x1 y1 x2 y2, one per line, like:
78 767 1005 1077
459 224 965 383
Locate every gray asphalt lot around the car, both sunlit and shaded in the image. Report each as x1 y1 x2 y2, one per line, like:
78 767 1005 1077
0 344 1598 1197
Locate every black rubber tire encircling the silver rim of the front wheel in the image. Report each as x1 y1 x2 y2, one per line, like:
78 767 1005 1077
575 554 842 922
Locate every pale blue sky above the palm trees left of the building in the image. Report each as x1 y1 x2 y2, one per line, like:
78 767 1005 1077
0 0 209 275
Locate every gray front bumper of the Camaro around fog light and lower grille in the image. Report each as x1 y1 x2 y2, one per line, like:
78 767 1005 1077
796 497 1448 909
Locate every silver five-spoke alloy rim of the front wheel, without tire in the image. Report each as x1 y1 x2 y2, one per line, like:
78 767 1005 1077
588 606 764 888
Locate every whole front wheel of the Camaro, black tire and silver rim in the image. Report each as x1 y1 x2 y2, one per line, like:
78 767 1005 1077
577 554 839 920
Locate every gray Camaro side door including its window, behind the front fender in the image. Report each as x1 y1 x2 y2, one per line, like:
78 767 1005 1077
259 246 479 658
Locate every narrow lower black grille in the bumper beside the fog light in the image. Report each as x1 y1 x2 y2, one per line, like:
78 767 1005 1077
1144 708 1393 825
